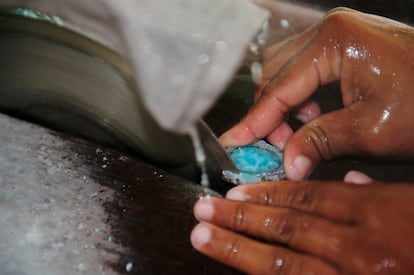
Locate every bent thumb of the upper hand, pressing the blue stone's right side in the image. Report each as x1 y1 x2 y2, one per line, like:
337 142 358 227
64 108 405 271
284 108 359 180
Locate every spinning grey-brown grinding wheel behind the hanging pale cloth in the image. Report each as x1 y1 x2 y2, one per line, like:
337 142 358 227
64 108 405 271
0 14 193 166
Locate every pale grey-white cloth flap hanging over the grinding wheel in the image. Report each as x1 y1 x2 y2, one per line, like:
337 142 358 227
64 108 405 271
0 0 268 132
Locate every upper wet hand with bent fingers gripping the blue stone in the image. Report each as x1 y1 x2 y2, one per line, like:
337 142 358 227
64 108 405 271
220 8 414 180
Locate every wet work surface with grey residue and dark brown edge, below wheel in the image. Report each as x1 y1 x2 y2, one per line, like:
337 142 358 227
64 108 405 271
0 114 237 275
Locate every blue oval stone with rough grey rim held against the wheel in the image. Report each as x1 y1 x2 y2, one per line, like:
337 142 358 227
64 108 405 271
222 140 285 184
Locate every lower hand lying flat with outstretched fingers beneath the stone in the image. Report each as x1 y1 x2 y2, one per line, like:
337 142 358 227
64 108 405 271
191 182 414 275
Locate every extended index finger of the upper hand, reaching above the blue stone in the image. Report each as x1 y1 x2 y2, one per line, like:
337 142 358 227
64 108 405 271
220 18 341 149
